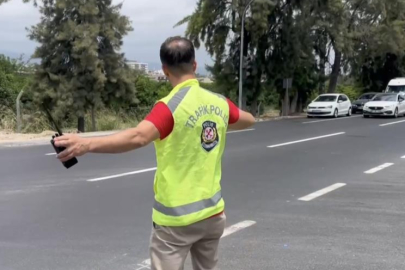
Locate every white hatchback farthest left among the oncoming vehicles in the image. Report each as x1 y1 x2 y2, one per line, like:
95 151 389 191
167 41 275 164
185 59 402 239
307 94 352 118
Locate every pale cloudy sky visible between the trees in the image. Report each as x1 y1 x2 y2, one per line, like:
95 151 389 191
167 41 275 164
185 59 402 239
0 0 212 73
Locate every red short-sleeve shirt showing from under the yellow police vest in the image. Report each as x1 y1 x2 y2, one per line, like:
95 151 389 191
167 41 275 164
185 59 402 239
145 99 239 140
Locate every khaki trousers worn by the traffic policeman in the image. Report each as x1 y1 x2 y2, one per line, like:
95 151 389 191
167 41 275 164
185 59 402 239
150 214 226 270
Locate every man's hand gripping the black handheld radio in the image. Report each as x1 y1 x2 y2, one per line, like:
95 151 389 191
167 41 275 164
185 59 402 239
54 134 89 162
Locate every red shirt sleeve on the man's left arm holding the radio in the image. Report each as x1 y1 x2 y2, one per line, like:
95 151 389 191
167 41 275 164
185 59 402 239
145 102 174 140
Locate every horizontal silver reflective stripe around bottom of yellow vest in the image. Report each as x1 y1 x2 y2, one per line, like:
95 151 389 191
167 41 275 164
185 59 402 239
153 191 222 217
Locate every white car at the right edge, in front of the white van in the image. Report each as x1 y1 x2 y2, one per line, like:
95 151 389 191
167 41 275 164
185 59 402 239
363 93 405 118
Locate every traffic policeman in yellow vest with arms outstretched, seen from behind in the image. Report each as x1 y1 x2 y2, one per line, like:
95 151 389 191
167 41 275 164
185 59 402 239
55 37 255 270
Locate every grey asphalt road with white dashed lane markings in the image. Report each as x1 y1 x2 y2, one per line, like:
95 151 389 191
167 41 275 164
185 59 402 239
0 114 405 270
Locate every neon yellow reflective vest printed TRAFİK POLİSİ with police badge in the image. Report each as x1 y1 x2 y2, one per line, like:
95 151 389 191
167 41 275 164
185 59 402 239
152 80 229 226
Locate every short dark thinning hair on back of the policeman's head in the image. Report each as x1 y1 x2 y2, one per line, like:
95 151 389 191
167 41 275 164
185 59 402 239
160 36 195 75
